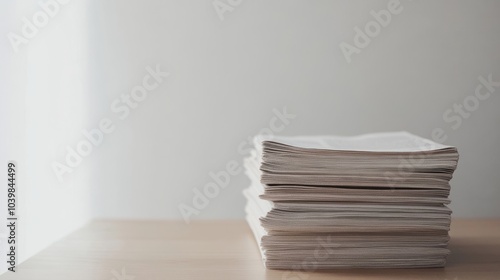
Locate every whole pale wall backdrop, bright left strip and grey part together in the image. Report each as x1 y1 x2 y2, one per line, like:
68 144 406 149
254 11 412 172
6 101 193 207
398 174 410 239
0 0 500 266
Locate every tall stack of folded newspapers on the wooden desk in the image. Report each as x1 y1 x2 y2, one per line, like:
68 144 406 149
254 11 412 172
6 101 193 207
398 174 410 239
244 132 458 269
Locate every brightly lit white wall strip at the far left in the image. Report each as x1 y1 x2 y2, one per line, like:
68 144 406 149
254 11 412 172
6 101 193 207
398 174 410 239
0 1 91 272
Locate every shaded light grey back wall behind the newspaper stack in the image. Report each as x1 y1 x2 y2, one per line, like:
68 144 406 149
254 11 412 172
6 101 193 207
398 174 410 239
87 0 500 218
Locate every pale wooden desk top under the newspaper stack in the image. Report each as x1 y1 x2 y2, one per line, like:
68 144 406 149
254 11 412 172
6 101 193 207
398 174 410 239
0 220 500 280
